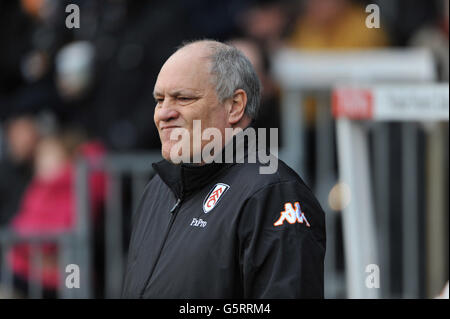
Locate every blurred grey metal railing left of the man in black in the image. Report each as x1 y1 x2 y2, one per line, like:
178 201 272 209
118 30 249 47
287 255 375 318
0 152 161 298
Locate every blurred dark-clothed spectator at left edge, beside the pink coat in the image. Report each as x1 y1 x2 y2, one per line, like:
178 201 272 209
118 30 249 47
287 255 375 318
0 116 39 227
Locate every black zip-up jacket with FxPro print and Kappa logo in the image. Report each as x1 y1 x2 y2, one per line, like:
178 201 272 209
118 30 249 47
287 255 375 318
122 134 325 298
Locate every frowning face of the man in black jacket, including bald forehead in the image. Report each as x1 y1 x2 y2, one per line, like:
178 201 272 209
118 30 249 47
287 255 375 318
154 45 231 160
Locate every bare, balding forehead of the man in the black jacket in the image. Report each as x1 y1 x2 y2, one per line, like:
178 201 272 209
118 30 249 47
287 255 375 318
154 48 213 94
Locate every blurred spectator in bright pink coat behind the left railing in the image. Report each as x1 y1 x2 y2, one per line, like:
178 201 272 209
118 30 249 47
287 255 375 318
10 133 105 292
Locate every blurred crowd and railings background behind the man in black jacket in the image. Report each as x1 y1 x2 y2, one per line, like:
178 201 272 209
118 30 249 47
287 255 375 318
0 0 449 298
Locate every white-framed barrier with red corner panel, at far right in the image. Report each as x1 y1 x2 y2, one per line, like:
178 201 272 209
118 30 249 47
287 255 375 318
333 83 449 298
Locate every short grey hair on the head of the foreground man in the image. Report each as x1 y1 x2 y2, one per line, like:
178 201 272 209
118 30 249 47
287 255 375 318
179 40 261 119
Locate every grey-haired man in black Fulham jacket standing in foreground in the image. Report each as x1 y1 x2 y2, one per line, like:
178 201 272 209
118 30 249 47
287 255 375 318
122 40 325 298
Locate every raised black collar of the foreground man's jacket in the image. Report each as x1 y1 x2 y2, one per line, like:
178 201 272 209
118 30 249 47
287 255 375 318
152 128 255 199
